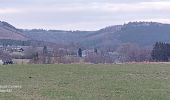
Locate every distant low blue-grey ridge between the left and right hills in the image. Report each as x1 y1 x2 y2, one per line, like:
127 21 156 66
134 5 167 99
21 29 93 44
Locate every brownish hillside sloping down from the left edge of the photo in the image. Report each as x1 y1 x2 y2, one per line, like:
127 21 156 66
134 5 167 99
0 21 28 41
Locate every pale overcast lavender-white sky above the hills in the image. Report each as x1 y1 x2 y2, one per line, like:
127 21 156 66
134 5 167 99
0 0 170 31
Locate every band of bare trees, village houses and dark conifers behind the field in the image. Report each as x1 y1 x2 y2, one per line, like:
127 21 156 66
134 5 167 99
0 42 170 65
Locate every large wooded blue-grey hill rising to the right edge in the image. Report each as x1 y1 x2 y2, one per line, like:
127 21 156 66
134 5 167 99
79 22 170 47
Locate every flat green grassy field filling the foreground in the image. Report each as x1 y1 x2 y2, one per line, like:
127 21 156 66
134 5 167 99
0 64 170 100
